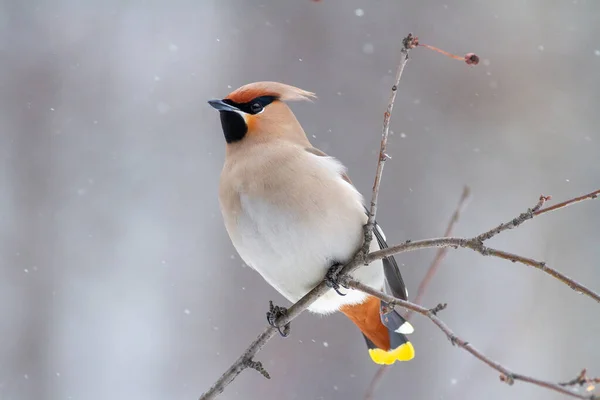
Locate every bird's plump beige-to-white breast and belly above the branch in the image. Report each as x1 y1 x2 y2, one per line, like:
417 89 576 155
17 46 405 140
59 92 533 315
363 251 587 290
220 145 366 308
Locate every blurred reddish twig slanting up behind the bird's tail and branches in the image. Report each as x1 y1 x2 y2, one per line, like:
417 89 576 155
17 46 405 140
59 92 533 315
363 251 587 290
364 186 471 400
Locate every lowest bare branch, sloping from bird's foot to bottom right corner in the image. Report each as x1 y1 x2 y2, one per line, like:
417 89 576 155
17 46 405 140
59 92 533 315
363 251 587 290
346 279 600 400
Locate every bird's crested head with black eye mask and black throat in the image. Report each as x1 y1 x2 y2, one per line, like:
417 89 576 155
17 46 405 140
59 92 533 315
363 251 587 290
208 82 315 144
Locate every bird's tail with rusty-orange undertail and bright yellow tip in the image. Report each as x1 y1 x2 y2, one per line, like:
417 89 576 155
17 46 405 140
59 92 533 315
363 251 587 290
340 296 415 365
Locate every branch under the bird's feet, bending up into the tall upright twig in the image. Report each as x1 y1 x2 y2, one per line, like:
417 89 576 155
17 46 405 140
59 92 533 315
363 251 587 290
200 34 413 400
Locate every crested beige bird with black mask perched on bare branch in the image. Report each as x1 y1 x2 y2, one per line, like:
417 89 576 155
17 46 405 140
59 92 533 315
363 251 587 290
208 81 415 365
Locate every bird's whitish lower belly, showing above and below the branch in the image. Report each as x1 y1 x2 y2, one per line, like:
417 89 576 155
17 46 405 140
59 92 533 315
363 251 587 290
232 195 383 313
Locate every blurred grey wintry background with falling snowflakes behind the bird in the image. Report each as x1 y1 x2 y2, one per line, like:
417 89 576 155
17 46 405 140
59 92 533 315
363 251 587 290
0 0 600 400
